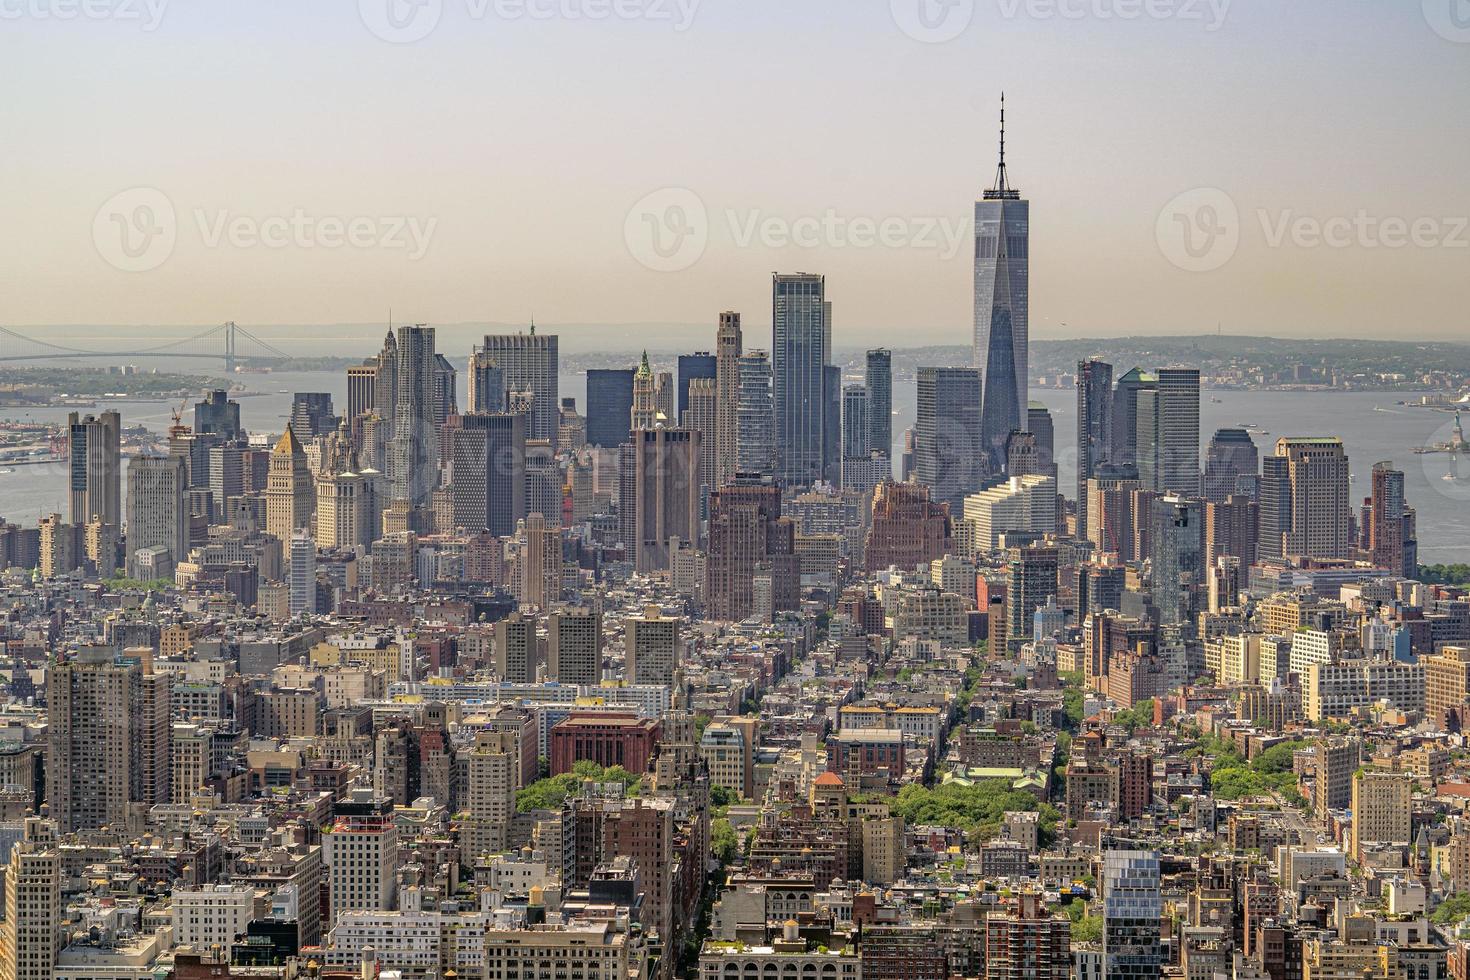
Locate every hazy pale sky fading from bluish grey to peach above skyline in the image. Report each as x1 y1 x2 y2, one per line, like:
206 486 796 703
0 0 1470 347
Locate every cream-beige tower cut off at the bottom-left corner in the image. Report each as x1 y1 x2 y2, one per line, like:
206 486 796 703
0 817 63 980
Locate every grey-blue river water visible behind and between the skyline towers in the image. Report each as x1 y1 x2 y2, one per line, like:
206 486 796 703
0 363 1470 563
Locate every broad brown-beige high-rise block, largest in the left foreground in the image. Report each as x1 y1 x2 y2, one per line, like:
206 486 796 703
46 648 171 833
